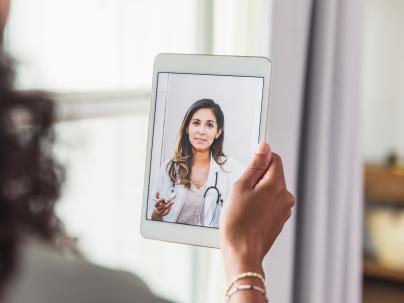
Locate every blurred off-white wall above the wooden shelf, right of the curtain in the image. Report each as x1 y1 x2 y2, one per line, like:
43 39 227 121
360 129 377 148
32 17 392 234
363 0 404 161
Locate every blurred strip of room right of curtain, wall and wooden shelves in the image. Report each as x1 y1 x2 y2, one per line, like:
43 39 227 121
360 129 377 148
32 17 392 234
362 0 404 302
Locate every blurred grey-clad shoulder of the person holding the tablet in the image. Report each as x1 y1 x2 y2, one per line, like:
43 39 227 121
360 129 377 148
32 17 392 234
6 242 172 303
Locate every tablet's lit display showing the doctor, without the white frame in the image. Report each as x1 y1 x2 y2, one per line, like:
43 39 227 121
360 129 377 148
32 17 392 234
147 72 264 228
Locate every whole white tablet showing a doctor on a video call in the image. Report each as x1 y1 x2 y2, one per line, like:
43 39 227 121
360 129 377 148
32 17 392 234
140 54 271 247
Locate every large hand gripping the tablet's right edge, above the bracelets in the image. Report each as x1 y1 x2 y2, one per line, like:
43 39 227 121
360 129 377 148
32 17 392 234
220 143 294 279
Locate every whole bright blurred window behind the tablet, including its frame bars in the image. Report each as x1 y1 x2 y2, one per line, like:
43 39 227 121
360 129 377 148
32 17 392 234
6 0 272 303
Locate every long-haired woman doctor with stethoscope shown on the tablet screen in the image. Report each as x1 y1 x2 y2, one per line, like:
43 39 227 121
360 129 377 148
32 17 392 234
151 99 243 228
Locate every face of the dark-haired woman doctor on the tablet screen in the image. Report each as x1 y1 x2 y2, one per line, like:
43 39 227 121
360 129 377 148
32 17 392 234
187 108 222 151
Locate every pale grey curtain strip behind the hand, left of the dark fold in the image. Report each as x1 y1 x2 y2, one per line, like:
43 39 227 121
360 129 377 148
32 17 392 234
264 0 310 303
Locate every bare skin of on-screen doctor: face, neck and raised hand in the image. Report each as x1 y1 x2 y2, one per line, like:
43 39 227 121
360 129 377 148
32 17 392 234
152 108 222 221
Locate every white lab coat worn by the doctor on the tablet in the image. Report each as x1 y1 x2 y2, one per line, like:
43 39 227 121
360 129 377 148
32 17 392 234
148 157 244 227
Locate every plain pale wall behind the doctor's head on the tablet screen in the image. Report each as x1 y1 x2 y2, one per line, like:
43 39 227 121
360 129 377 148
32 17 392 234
156 74 263 165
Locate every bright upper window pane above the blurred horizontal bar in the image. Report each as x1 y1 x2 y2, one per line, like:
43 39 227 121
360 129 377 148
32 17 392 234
4 0 199 92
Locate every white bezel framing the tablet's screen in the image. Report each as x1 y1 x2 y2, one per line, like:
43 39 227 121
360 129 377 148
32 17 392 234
140 54 271 248
